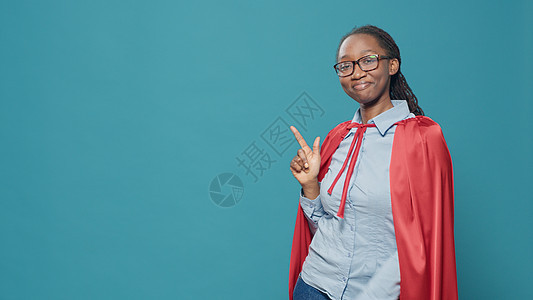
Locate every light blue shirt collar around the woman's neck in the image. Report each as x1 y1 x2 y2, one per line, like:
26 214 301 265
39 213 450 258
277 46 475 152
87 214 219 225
346 100 411 137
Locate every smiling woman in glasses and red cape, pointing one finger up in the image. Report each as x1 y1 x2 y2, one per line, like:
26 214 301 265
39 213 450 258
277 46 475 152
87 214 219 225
289 25 457 300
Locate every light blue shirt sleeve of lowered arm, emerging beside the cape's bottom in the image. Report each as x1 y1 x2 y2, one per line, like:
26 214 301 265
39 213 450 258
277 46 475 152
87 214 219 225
357 251 400 300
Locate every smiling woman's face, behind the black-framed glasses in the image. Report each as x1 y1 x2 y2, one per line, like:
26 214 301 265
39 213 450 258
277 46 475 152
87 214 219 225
337 34 399 105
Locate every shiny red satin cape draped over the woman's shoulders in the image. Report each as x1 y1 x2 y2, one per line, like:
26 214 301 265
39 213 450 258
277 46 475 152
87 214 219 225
289 116 457 300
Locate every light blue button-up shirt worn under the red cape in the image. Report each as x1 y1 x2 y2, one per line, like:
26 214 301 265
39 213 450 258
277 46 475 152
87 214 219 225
300 100 414 300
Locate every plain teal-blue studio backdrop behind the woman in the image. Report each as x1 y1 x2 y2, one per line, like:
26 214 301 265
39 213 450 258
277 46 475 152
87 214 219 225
0 0 533 299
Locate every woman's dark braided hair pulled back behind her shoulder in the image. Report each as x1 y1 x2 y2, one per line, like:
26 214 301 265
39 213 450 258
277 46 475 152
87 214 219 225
335 25 424 116
